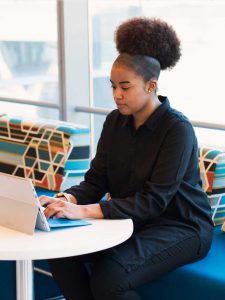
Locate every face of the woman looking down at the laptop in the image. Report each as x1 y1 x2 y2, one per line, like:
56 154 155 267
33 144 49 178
110 66 150 116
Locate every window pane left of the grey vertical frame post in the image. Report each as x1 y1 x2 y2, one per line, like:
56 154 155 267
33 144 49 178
0 0 59 118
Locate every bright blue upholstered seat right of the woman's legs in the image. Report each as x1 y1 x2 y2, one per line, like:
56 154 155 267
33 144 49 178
138 226 225 300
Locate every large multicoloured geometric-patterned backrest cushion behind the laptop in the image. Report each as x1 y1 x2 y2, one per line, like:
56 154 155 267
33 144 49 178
0 117 90 191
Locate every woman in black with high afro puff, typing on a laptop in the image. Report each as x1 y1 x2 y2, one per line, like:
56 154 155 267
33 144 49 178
41 18 213 300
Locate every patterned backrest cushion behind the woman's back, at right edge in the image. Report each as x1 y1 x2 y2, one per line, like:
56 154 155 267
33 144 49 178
199 147 225 225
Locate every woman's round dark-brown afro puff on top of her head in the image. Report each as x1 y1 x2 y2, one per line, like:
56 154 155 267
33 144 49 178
115 17 181 70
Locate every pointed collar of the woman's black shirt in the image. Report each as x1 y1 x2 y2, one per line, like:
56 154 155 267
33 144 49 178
121 96 170 130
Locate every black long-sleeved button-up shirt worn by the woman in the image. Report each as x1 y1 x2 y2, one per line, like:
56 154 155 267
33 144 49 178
66 96 212 241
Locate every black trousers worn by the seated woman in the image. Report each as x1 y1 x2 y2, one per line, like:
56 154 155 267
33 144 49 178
49 227 210 300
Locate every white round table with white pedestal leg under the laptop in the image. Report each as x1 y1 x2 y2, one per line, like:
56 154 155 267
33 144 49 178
0 219 133 300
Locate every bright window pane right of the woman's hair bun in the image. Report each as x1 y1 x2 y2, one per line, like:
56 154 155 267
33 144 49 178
142 0 225 123
